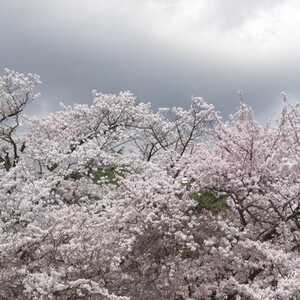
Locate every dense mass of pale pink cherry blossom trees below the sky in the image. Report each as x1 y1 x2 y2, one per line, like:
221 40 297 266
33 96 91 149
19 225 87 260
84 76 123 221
0 70 300 300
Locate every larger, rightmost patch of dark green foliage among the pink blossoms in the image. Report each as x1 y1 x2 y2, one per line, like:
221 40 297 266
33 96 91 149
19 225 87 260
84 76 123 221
192 191 229 213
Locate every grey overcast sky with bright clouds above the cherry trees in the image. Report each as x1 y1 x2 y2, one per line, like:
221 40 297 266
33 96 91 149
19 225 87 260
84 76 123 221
0 0 300 118
